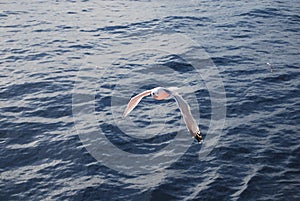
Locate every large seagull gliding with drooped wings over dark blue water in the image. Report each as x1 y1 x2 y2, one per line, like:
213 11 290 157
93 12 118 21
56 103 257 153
122 87 202 143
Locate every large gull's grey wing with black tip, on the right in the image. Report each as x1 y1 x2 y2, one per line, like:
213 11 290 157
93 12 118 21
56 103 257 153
172 91 202 142
